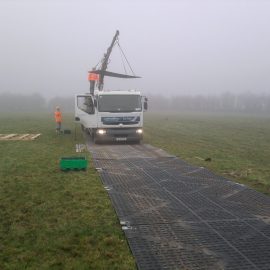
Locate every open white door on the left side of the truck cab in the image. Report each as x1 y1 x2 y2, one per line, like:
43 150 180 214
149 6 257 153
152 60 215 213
75 95 97 128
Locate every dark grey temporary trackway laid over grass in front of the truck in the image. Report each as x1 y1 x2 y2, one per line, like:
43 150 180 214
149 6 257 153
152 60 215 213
87 142 270 270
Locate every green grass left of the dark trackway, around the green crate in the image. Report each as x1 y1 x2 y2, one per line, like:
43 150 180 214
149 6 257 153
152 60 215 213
0 115 135 270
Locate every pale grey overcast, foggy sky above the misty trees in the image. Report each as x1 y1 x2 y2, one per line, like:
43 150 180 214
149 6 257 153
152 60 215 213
0 0 270 97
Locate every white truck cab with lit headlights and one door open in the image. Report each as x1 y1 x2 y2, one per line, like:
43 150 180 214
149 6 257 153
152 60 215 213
75 90 147 143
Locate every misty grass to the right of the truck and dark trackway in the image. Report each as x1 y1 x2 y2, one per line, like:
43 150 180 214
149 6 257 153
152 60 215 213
145 113 270 195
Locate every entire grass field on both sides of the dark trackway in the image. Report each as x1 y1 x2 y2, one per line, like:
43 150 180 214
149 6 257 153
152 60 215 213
0 113 270 269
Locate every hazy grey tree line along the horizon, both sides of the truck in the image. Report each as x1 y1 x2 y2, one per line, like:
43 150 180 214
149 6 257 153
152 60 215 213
0 92 270 113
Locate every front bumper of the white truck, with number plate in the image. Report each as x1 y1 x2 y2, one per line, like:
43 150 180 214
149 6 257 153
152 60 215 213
96 128 143 142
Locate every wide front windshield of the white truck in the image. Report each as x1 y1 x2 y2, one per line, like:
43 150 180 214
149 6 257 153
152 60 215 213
98 95 142 112
